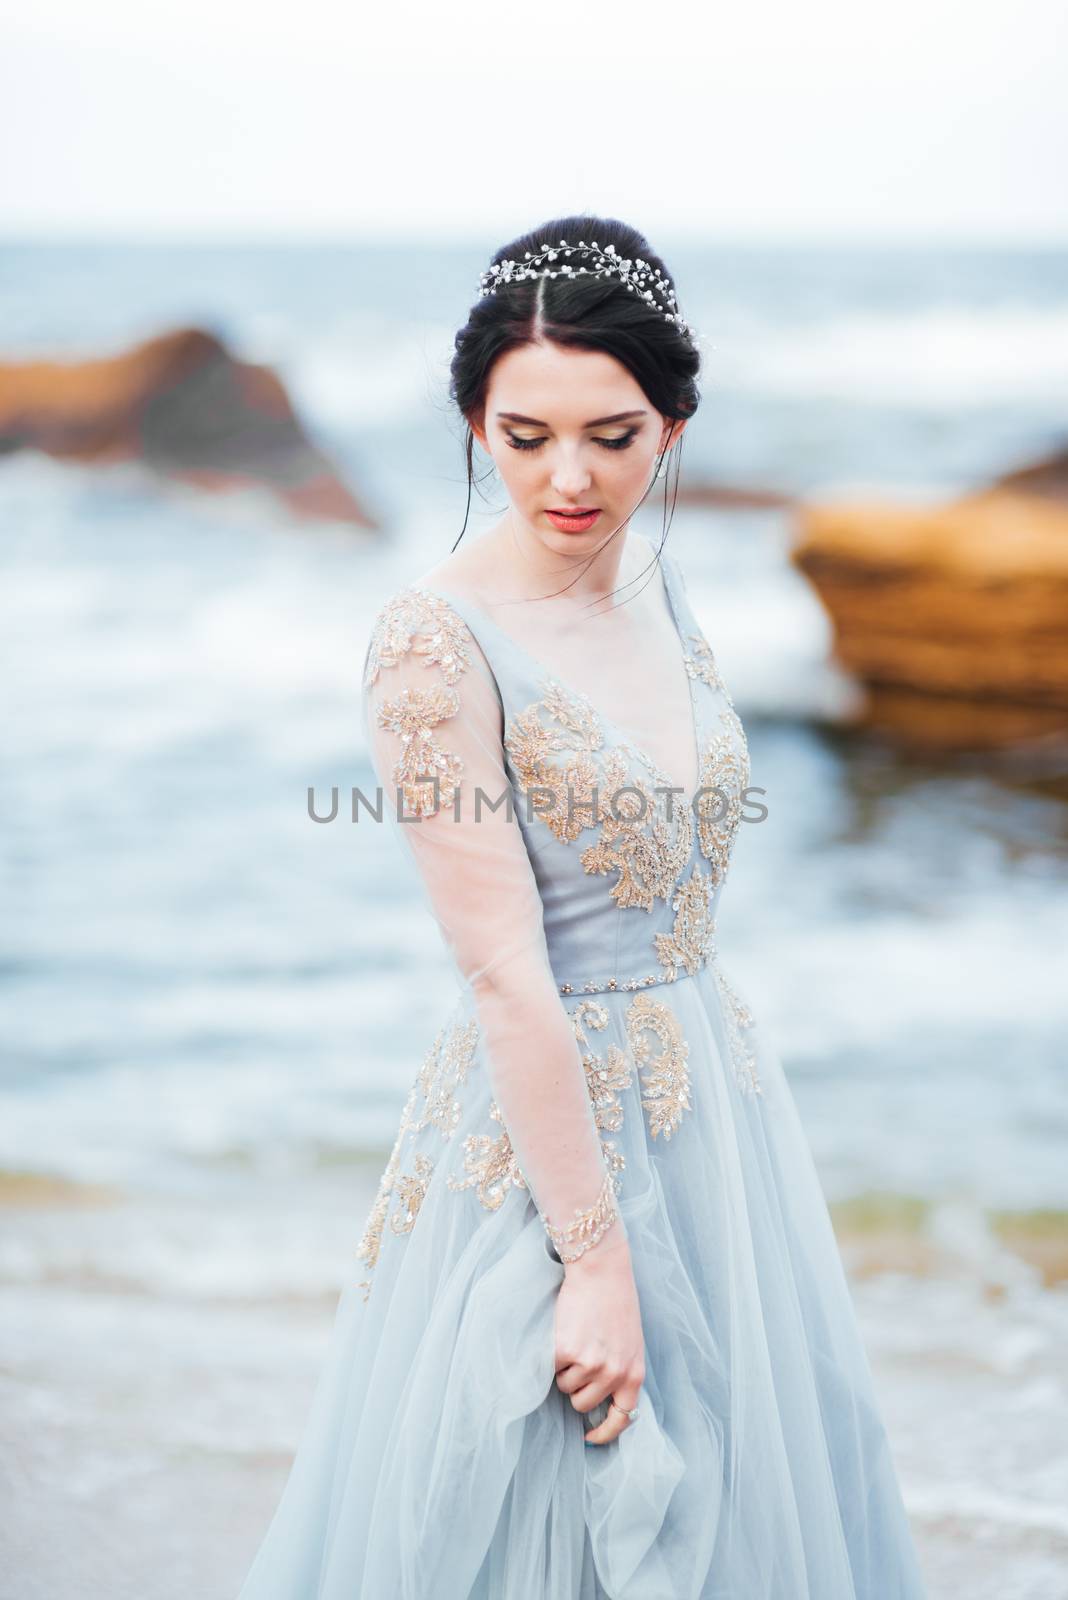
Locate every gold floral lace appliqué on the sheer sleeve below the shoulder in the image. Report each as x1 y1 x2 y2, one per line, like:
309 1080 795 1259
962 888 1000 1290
365 589 473 816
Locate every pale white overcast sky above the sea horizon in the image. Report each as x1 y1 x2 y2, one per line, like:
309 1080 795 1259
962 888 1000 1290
0 0 1068 243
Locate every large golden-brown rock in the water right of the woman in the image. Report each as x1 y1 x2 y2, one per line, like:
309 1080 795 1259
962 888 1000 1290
791 464 1068 747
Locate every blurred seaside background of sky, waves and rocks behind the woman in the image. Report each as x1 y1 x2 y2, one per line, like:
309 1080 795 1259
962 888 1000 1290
0 0 1068 1600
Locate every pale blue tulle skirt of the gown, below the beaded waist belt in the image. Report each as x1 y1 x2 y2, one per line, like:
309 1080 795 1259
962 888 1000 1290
238 962 924 1600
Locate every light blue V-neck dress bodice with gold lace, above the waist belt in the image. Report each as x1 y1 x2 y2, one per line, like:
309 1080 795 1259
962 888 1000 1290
409 555 750 994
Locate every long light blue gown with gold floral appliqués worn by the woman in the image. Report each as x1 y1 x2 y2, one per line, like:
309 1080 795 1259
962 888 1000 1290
238 554 924 1600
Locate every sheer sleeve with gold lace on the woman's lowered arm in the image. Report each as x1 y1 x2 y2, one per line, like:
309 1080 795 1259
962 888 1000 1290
361 589 624 1261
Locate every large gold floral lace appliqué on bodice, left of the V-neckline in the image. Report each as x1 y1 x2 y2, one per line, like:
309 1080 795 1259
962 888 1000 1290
505 678 694 910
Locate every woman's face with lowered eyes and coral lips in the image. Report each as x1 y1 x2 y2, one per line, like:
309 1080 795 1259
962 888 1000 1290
472 342 686 554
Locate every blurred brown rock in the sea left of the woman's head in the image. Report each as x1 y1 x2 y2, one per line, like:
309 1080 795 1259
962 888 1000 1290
0 328 376 528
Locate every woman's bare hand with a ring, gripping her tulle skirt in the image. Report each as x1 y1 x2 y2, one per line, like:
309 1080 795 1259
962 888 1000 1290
556 1222 646 1445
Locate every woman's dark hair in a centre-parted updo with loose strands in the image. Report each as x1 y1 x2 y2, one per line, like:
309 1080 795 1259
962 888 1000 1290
449 214 700 582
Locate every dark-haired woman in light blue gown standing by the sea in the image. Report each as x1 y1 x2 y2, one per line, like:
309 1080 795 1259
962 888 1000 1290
240 216 924 1600
